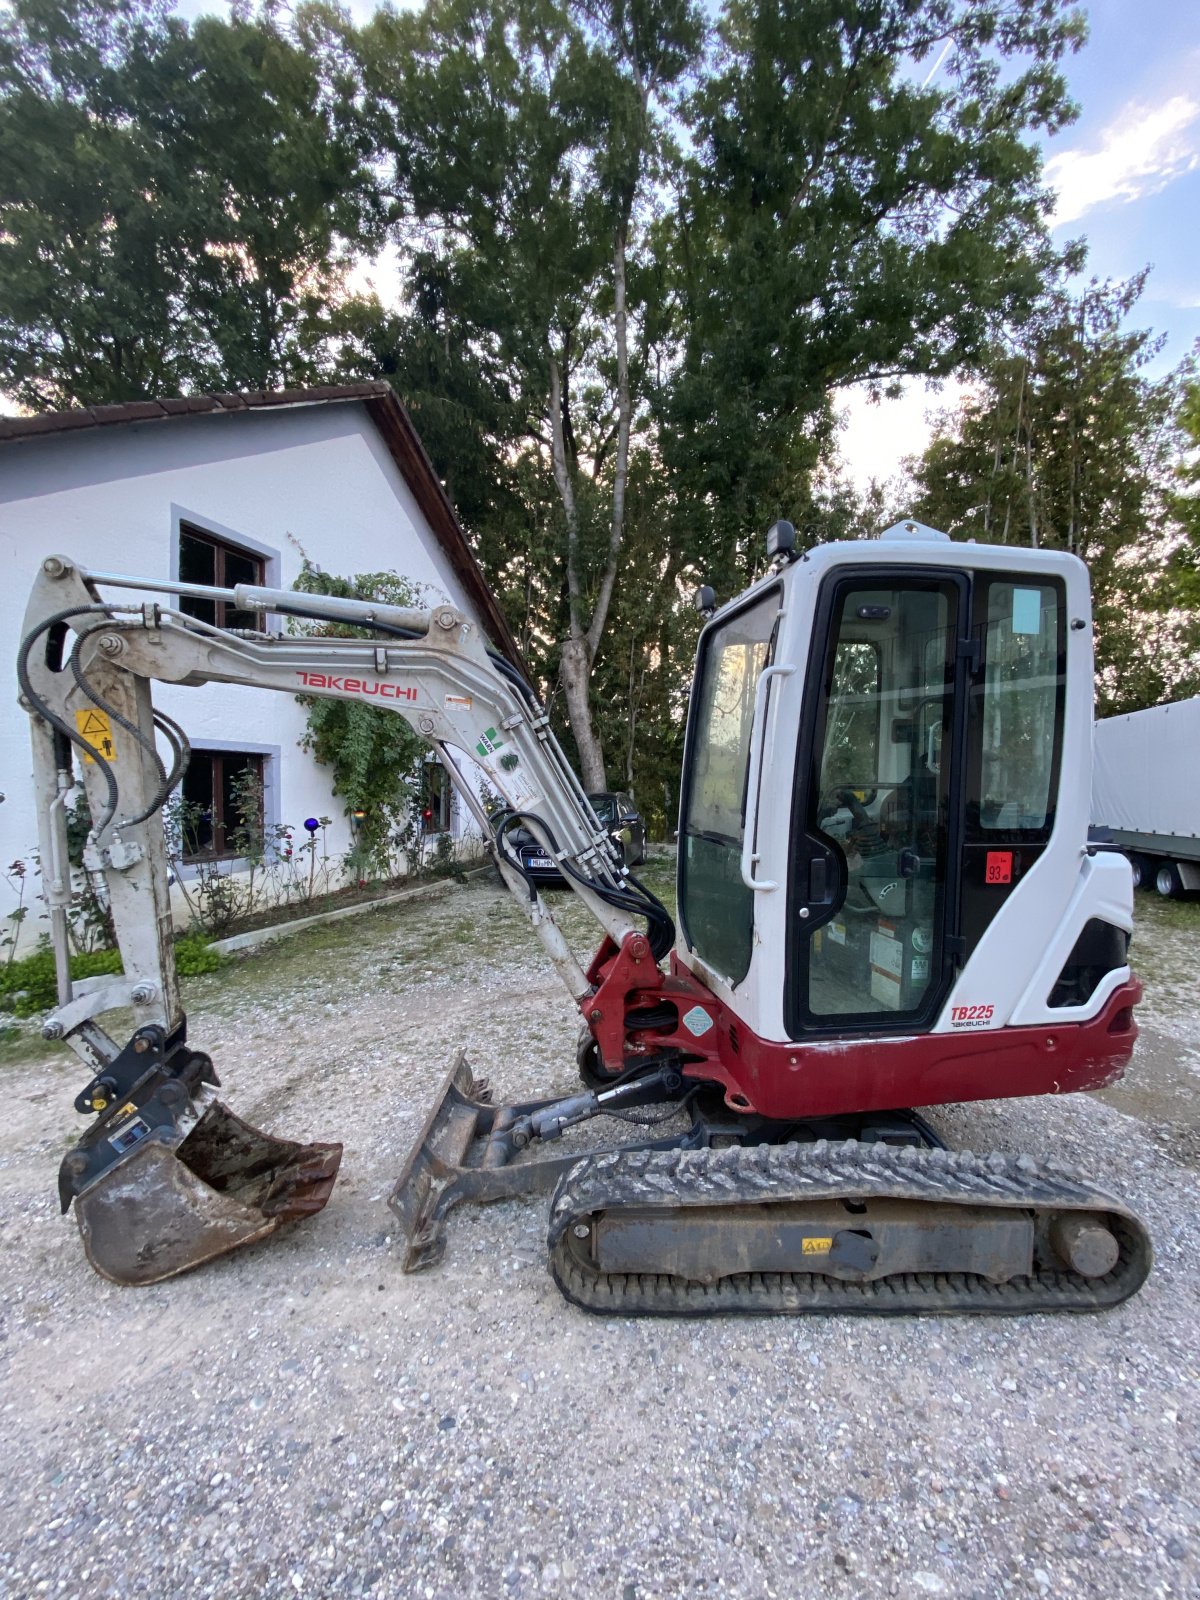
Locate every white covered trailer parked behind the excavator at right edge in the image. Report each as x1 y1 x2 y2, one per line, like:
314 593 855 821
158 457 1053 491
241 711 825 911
1091 694 1200 899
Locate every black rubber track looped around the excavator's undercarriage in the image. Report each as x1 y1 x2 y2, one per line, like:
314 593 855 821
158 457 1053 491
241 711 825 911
549 1139 1154 1317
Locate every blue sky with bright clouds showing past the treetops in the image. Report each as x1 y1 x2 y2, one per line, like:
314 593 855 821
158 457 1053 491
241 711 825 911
178 0 1200 488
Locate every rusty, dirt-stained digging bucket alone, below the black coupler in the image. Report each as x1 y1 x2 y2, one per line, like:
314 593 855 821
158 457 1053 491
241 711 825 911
75 1101 342 1285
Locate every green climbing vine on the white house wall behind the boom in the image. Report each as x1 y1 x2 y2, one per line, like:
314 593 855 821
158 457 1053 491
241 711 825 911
293 557 426 880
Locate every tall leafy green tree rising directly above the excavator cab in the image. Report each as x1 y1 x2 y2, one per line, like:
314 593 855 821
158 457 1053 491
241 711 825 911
662 0 1083 588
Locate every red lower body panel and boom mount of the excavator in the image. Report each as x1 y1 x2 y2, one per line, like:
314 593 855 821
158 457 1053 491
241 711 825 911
584 934 1142 1120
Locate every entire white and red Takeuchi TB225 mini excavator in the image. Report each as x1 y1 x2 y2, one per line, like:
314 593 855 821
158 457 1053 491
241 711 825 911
18 523 1150 1315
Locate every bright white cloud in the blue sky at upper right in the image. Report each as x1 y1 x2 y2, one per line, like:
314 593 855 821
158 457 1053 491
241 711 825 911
1046 94 1200 227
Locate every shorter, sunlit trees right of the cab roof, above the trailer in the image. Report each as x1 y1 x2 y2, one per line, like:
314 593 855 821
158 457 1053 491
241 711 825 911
912 274 1194 714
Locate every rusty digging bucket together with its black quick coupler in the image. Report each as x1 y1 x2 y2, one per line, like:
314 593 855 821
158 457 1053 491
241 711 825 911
59 1027 342 1285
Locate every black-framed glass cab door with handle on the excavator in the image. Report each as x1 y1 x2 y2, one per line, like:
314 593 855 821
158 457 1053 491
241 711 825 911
786 568 971 1037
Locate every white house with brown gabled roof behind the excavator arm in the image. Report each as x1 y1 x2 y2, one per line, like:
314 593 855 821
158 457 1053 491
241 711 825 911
0 384 520 931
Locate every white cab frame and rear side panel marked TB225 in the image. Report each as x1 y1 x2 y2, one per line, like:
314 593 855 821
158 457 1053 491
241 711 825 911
678 536 1133 1042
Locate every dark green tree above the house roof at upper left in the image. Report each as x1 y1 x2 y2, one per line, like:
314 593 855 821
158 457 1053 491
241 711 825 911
0 0 379 411
